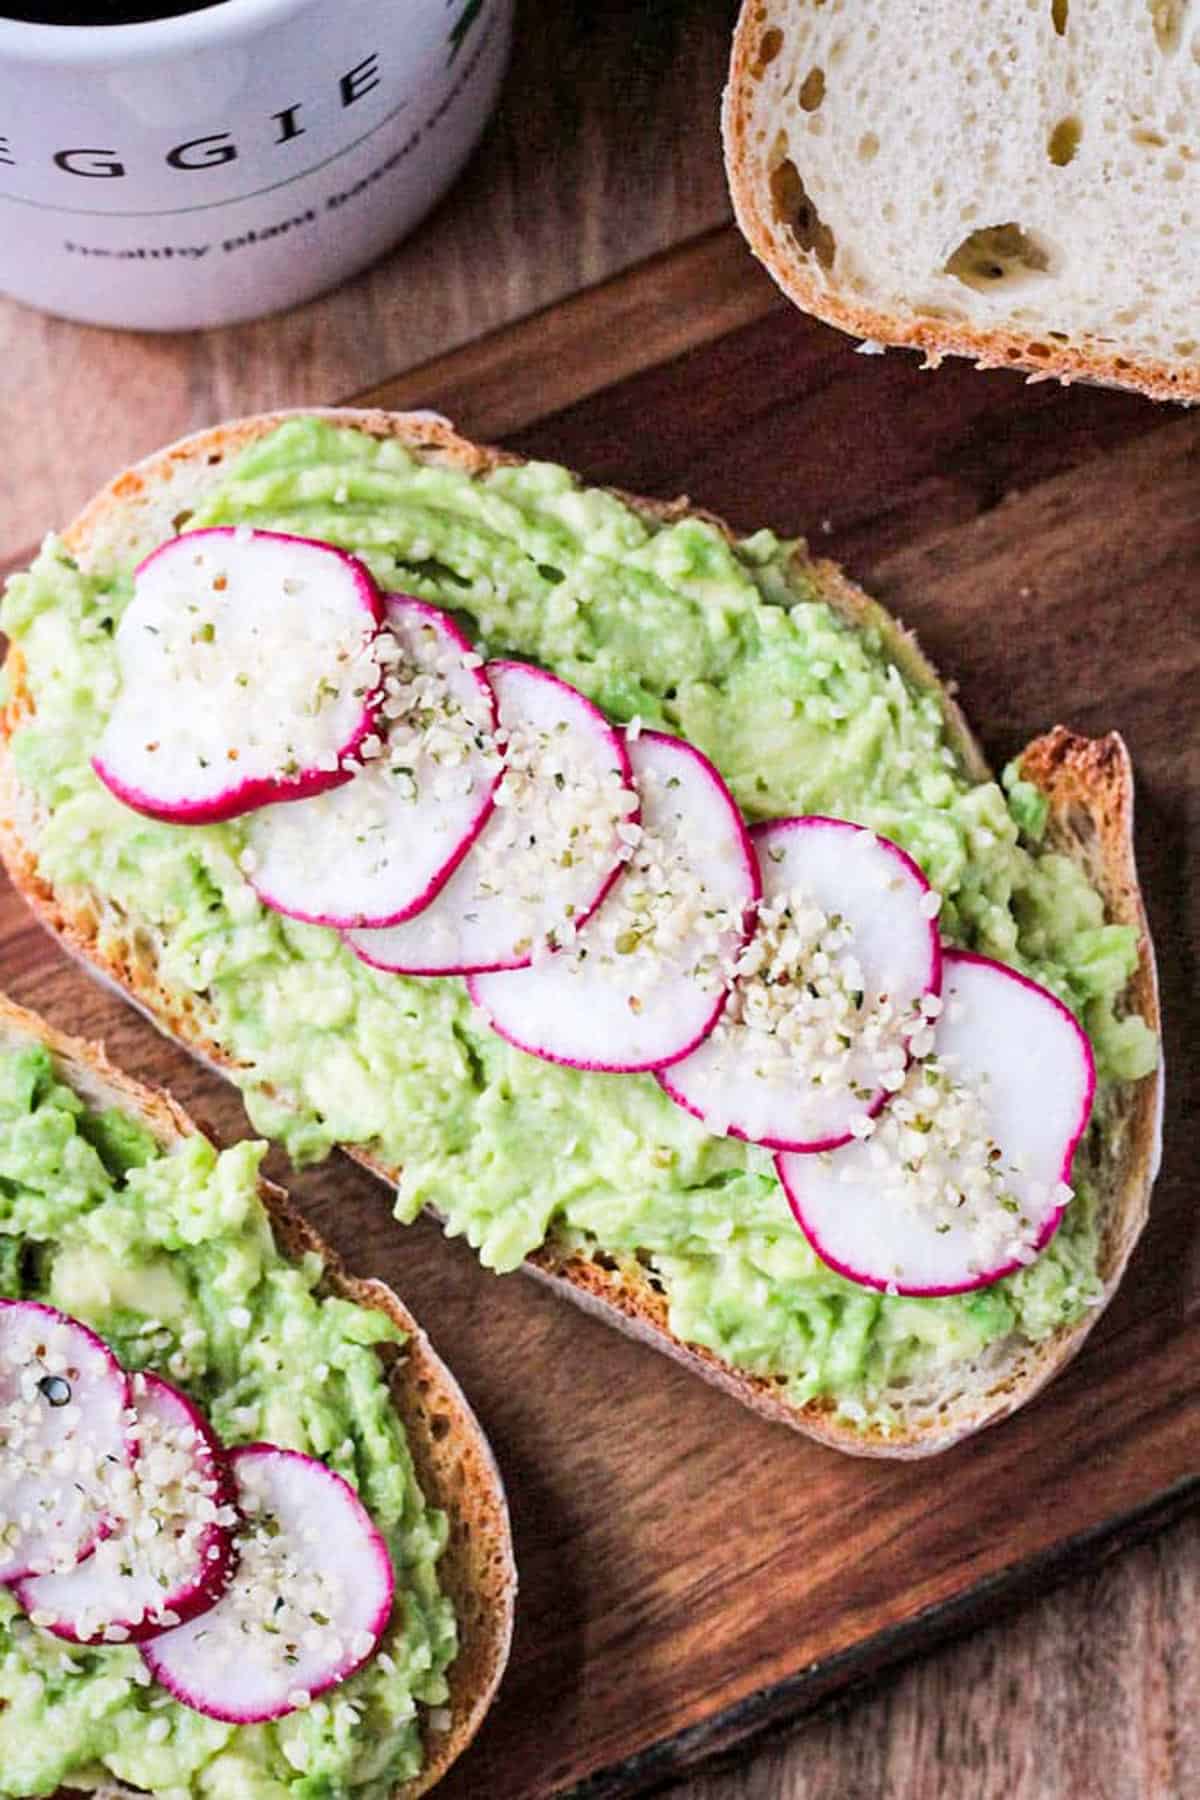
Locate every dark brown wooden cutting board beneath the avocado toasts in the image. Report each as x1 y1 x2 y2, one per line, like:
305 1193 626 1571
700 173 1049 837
0 230 1200 1800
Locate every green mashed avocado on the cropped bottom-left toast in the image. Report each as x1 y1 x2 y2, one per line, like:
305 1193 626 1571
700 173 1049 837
0 1046 455 1800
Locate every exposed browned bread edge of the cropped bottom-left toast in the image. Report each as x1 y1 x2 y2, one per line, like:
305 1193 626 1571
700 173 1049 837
0 994 516 1800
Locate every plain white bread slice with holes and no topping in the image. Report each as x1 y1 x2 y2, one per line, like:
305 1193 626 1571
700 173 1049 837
723 0 1200 400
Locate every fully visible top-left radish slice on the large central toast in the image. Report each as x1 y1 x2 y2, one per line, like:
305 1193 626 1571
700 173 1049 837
92 526 383 824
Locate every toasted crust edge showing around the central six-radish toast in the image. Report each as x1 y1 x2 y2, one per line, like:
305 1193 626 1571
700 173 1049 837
0 407 1162 1458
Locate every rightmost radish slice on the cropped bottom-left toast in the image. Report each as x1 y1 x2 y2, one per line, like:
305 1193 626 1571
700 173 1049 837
142 1444 394 1724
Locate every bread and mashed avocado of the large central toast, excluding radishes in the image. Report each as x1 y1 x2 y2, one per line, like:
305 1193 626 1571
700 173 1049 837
4 412 1159 1454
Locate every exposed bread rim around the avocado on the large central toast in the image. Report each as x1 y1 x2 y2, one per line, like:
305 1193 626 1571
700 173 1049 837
0 409 1160 1456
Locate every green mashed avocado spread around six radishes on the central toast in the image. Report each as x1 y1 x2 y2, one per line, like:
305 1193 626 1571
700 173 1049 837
4 419 1155 1426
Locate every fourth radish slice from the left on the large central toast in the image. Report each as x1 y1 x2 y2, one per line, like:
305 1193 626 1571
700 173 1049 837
468 731 759 1075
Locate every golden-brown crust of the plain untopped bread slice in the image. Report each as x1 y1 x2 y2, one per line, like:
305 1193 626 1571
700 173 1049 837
721 0 1200 403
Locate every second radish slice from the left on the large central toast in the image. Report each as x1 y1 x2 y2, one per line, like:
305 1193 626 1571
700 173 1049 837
241 594 500 927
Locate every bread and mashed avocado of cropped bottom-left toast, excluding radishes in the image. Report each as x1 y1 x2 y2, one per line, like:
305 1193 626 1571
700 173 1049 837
0 997 516 1800
